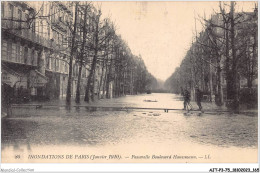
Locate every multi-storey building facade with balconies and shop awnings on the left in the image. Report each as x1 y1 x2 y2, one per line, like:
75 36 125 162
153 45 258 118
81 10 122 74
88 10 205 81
1 1 91 102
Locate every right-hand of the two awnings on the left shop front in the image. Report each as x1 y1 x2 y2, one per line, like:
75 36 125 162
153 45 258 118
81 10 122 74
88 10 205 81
29 70 48 88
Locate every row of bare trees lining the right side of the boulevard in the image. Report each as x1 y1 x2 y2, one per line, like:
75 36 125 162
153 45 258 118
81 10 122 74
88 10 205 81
167 2 257 112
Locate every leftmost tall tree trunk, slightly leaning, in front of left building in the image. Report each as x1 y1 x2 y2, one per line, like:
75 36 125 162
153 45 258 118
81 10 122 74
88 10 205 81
66 2 78 105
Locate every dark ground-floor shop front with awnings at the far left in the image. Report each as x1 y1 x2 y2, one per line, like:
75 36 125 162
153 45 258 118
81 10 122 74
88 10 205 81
1 63 48 106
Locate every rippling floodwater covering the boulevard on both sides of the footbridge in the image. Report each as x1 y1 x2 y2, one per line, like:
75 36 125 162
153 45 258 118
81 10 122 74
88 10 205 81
2 94 257 155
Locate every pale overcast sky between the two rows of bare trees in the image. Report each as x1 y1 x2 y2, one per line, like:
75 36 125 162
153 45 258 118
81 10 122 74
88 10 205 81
98 1 254 80
